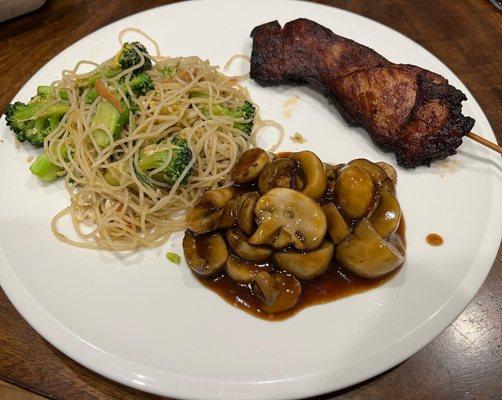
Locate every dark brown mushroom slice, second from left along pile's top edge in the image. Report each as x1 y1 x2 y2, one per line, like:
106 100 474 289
258 158 300 194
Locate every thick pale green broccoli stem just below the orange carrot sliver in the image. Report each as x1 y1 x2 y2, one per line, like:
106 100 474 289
91 100 129 147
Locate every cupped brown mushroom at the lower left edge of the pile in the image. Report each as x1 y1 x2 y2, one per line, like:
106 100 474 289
183 230 228 276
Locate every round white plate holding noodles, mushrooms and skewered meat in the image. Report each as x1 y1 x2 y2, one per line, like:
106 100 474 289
0 0 502 400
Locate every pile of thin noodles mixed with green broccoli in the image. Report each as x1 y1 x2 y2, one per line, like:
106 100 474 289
5 37 266 250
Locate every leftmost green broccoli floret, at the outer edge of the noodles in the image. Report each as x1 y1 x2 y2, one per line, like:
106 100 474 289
5 100 69 147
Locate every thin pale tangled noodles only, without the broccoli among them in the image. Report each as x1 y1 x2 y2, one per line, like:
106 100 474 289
44 38 283 251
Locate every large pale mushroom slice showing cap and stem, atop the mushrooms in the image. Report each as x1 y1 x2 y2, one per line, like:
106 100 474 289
248 188 327 250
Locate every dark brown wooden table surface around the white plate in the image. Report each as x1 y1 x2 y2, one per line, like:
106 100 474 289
0 0 502 400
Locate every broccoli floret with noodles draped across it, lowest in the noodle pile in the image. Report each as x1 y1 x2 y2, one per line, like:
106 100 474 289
138 137 192 186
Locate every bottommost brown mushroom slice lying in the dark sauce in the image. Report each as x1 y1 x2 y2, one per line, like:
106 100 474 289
253 271 302 313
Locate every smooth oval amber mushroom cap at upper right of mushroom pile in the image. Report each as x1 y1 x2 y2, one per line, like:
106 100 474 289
336 165 376 219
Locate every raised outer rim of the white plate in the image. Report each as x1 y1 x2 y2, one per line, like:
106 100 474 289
0 0 502 400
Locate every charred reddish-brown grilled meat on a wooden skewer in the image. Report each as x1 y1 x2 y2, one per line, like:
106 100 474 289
251 19 474 168
